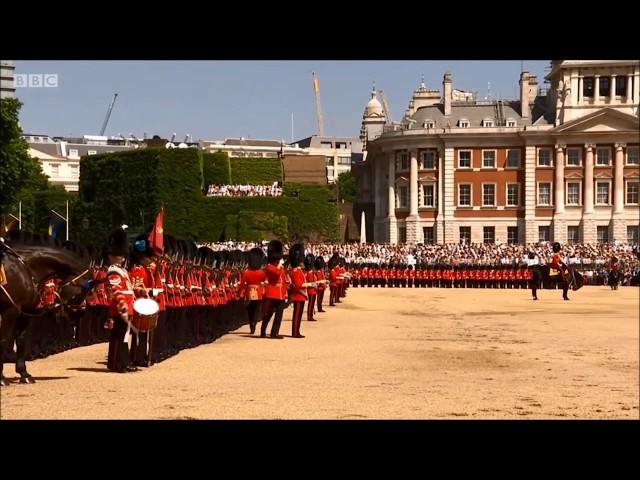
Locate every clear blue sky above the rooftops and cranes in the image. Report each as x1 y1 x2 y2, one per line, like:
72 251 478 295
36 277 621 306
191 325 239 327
15 60 549 142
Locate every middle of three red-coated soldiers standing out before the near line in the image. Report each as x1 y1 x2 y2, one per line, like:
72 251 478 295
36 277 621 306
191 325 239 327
260 240 287 338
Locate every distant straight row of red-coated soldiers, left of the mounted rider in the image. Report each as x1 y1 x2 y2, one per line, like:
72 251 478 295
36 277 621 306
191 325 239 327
350 264 533 288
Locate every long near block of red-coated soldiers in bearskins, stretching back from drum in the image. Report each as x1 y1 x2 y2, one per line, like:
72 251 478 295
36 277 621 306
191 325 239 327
97 229 347 372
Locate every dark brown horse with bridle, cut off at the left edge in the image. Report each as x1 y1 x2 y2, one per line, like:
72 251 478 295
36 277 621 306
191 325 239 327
0 234 89 385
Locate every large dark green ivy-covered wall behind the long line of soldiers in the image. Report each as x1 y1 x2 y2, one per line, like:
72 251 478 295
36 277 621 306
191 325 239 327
72 149 338 245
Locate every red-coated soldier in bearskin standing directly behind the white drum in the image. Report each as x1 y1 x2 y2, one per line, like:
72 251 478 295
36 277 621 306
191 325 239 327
129 234 157 367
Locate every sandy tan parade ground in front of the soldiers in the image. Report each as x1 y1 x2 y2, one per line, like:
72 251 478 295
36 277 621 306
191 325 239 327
0 287 640 419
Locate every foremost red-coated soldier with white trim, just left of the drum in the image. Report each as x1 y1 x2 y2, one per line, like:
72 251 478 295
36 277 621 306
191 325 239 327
103 228 138 373
